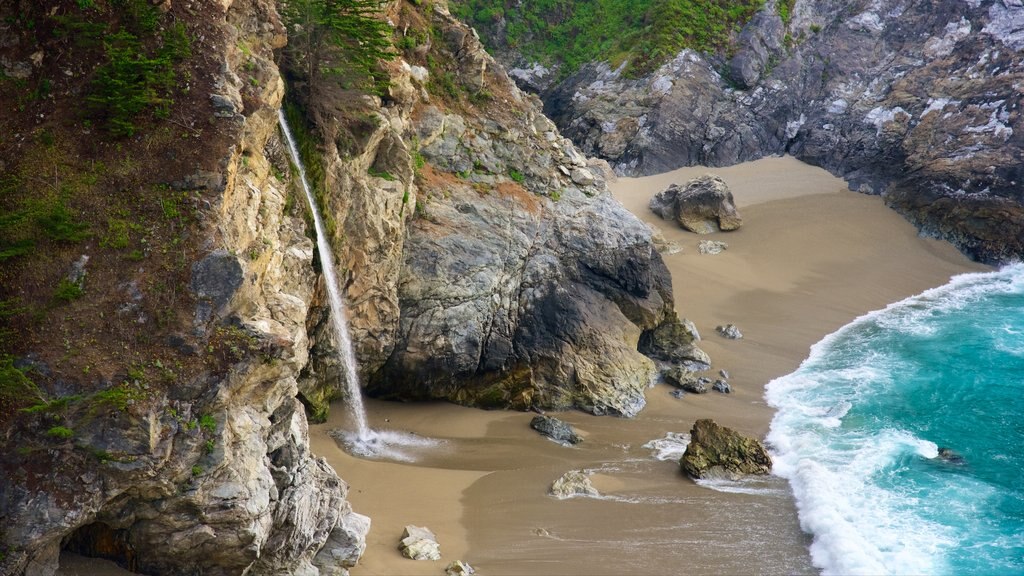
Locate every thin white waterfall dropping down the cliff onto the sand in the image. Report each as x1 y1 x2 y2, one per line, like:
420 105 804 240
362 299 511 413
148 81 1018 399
278 110 373 442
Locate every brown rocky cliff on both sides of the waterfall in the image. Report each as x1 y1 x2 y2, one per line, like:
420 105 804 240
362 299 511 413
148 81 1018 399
0 0 710 574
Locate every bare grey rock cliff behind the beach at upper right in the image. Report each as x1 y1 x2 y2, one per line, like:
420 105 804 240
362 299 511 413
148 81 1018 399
508 0 1024 261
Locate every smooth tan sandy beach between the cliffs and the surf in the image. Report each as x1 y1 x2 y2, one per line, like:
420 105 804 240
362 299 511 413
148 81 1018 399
311 158 984 576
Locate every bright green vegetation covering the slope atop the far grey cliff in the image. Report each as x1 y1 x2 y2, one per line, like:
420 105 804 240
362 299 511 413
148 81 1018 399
452 0 765 76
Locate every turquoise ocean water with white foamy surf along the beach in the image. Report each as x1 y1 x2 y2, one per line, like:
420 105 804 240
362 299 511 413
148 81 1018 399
766 264 1024 575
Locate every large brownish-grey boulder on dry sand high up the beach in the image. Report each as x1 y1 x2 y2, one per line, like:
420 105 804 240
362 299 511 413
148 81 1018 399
649 174 743 234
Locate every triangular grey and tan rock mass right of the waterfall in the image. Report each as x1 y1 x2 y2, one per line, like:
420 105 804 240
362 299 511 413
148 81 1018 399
299 0 707 415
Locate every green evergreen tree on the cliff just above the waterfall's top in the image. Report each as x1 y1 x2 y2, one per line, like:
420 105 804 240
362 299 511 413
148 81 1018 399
282 0 394 93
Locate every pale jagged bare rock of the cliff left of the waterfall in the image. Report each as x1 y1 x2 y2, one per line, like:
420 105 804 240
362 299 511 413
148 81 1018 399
0 0 369 575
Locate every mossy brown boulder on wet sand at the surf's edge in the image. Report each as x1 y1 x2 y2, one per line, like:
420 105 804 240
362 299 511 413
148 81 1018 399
679 419 771 480
